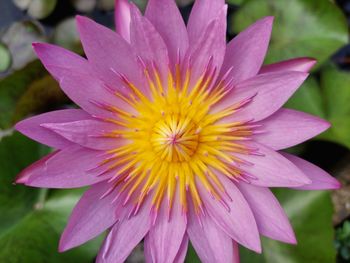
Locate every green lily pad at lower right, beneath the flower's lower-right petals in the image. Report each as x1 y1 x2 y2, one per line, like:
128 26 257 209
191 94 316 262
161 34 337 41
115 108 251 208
241 189 336 263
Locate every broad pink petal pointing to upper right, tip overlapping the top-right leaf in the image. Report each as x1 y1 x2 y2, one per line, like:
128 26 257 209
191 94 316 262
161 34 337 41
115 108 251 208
221 17 273 85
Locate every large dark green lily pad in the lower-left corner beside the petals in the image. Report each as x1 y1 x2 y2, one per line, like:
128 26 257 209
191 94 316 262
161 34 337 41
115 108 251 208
0 133 100 263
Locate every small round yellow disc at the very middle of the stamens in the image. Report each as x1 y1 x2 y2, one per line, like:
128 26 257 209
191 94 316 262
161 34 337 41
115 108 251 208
150 114 199 162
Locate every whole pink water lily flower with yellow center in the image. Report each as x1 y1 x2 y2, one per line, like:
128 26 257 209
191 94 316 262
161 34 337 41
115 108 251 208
16 0 339 263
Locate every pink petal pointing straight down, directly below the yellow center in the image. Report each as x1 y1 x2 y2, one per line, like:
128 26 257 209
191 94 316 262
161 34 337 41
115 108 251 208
145 195 186 263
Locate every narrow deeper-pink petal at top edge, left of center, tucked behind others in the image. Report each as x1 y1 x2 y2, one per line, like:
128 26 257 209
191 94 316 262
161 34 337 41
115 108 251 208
114 0 130 42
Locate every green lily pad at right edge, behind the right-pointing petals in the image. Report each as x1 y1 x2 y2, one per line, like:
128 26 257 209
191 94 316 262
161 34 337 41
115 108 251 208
285 65 350 151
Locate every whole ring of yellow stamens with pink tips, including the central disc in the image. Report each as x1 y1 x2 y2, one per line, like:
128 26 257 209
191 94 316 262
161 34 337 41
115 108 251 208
93 60 255 219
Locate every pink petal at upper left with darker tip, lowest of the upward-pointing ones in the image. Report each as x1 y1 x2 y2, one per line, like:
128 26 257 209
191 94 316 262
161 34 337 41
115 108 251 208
33 43 128 117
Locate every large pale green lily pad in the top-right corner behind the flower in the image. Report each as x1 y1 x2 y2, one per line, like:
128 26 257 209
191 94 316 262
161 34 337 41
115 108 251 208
233 0 348 67
